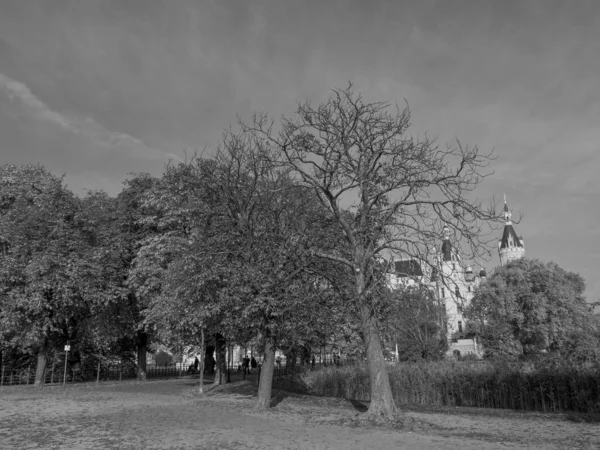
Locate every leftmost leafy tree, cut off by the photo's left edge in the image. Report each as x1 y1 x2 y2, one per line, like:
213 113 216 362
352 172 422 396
0 165 104 385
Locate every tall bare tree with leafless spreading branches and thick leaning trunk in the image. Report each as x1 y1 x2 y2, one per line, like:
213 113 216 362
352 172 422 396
242 84 498 416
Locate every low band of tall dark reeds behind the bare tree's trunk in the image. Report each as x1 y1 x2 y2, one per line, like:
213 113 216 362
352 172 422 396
302 360 600 413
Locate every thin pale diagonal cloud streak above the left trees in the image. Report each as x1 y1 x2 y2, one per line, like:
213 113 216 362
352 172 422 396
0 73 181 160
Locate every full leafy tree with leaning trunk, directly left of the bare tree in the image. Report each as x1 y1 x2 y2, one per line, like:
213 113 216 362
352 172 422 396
136 133 342 408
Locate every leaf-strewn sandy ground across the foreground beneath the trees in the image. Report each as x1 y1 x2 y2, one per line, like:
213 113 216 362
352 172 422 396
0 379 600 450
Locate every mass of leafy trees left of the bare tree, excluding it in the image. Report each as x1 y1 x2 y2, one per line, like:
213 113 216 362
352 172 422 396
0 157 358 394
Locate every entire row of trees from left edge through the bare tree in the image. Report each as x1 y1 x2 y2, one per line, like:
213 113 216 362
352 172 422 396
0 86 498 415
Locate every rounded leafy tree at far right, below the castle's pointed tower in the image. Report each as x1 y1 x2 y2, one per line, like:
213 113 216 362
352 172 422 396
466 258 599 356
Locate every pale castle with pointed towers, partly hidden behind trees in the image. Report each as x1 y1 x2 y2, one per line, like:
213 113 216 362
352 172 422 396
388 199 525 357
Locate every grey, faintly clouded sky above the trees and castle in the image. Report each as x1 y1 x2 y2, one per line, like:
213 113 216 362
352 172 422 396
0 0 600 300
